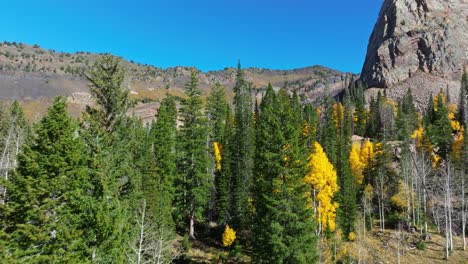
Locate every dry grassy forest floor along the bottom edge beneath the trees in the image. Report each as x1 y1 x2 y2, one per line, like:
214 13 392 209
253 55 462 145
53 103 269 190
176 226 468 264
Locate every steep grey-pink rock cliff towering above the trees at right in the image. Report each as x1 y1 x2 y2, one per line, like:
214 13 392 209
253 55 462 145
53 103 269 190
361 0 468 103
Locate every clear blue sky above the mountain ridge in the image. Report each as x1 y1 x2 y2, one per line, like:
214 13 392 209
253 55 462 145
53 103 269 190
0 0 383 73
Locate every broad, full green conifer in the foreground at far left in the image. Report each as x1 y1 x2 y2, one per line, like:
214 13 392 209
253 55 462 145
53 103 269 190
3 97 90 262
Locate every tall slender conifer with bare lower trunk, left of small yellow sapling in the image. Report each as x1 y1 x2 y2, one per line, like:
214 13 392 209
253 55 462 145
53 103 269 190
177 72 212 239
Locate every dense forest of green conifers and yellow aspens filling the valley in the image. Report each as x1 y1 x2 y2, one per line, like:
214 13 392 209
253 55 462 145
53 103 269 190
0 55 468 263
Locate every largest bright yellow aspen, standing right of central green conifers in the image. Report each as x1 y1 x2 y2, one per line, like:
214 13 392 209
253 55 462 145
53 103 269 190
305 142 338 231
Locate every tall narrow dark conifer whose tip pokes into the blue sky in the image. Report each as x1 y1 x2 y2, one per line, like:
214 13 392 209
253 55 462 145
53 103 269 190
231 63 255 229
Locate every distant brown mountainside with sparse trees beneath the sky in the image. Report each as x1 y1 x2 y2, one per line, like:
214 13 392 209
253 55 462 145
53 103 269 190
0 42 355 119
